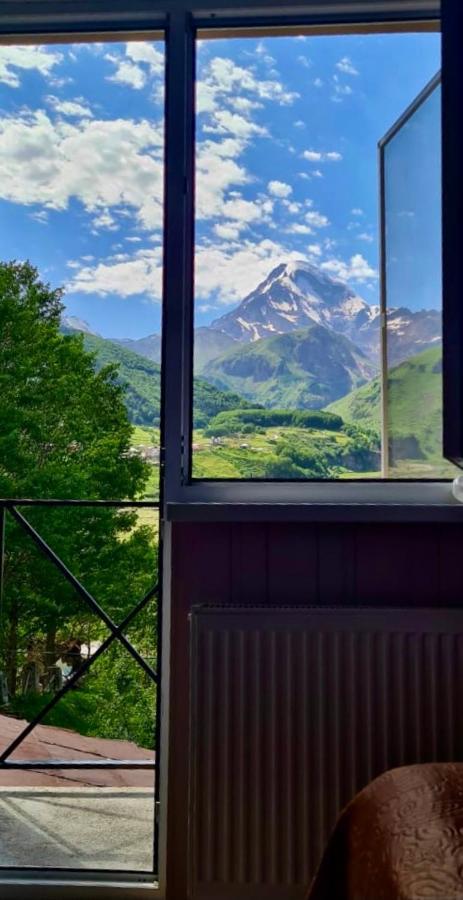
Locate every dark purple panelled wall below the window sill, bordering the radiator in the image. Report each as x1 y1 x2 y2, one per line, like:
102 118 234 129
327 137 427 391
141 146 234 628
167 523 463 900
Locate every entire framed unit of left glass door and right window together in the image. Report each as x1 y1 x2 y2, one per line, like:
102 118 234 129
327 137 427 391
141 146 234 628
0 0 463 896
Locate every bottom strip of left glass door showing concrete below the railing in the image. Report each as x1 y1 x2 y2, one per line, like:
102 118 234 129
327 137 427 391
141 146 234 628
0 769 154 873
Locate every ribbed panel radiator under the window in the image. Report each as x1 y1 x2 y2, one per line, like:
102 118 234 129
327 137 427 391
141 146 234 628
189 607 463 900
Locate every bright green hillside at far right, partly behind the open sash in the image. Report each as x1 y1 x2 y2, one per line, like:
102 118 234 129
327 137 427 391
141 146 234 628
327 345 442 460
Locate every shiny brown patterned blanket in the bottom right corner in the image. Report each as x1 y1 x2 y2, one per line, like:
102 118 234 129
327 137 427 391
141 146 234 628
308 763 463 900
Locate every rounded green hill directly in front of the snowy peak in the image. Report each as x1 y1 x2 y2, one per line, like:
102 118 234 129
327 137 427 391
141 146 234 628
202 325 375 409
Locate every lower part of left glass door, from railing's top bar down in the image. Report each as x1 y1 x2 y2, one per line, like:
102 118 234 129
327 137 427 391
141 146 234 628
0 508 157 871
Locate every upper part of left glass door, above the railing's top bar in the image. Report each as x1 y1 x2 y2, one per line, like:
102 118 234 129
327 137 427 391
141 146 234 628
0 40 164 499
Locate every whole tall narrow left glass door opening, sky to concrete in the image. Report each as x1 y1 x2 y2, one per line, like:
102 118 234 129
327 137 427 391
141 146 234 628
0 33 165 881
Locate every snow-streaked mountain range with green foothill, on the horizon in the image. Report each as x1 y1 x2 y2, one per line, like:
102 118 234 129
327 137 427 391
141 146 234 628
63 260 441 408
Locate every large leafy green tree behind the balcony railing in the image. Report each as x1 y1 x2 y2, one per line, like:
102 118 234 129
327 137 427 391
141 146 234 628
0 262 156 740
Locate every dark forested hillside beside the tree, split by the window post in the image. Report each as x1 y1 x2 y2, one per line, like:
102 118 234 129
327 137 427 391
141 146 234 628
78 331 256 428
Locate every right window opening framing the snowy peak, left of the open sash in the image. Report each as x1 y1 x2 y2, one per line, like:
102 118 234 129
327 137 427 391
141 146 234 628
192 33 440 479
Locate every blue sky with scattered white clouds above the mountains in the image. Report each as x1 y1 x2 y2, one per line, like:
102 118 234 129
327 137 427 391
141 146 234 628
0 34 440 337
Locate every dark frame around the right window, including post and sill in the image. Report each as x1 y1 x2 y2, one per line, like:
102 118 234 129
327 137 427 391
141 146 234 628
163 0 461 519
